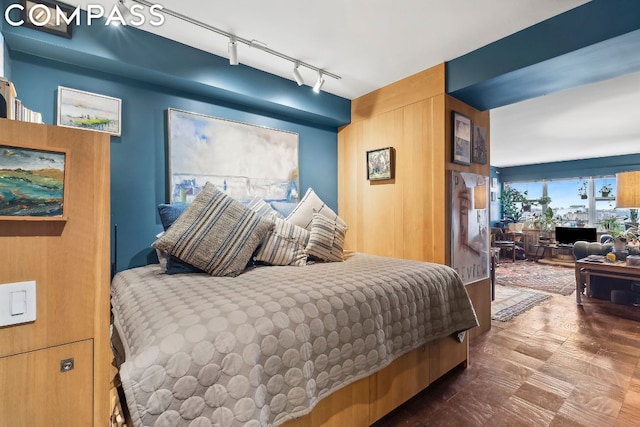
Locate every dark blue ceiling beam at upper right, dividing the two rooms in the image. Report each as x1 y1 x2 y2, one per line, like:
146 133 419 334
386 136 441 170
446 0 640 110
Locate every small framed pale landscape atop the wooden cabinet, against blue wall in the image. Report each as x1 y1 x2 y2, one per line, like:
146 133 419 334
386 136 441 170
58 86 122 136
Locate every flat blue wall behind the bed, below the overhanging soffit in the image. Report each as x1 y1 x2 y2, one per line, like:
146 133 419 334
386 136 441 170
11 51 338 270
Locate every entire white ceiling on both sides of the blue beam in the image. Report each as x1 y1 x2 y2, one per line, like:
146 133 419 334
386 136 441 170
67 0 640 166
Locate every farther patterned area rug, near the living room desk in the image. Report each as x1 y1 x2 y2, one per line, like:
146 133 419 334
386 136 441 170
496 261 576 295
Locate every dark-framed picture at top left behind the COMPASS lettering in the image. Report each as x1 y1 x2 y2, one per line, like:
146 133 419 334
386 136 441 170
20 0 73 39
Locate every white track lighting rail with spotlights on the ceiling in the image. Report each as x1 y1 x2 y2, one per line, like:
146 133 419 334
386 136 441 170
124 0 341 92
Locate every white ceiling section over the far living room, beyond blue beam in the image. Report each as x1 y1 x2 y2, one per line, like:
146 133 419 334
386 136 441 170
491 73 640 167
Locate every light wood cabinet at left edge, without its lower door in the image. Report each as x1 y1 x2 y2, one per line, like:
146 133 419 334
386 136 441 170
0 119 112 426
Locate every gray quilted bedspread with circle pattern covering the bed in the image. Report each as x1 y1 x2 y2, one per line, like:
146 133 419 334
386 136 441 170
111 254 477 427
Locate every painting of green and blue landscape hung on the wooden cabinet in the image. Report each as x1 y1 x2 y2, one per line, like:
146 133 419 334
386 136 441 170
0 145 69 220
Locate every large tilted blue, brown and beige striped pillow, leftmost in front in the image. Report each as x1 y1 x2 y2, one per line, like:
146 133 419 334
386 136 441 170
153 182 273 276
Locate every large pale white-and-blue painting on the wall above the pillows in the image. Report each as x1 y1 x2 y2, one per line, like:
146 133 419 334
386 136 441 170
167 108 300 203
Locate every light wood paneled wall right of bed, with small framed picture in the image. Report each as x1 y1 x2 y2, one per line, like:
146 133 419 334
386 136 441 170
338 64 491 336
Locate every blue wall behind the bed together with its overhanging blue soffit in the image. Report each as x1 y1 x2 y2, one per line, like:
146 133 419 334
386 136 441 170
0 1 351 270
